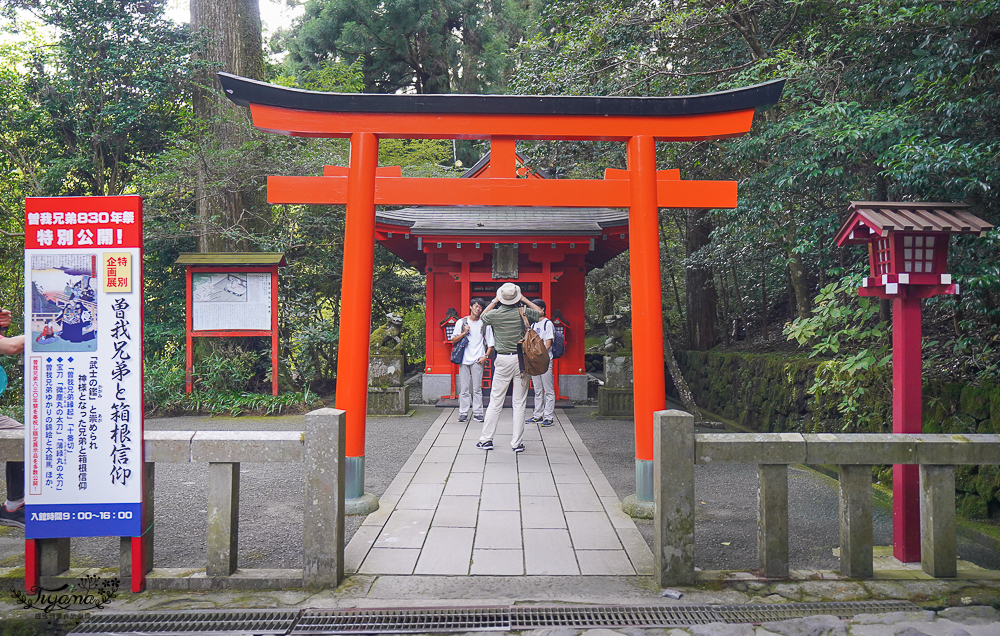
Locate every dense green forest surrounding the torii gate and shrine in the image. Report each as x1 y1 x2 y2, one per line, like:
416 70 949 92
0 0 1000 430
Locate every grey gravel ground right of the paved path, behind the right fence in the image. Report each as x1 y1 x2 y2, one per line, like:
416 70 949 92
566 408 1000 570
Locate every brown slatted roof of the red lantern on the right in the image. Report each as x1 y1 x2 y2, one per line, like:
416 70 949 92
835 201 993 246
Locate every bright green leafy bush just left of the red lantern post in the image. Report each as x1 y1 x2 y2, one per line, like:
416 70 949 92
785 277 892 432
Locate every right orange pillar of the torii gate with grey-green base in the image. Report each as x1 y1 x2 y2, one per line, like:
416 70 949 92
627 135 666 502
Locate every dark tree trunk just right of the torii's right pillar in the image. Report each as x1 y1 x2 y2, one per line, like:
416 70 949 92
685 210 719 351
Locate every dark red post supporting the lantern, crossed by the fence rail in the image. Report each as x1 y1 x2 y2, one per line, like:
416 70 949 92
892 297 923 563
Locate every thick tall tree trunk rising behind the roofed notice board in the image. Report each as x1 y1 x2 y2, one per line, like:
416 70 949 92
191 0 267 252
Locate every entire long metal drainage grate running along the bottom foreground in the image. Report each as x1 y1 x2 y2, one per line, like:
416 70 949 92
70 601 919 636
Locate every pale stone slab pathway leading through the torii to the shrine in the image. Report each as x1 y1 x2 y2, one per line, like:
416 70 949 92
345 409 654 576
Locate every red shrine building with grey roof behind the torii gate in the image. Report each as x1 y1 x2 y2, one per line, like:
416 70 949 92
375 154 628 400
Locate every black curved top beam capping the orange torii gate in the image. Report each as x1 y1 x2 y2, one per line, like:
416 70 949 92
218 73 785 117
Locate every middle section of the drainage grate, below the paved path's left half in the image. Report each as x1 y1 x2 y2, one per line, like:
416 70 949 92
291 607 510 635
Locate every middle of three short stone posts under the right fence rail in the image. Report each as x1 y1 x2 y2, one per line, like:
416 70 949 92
839 464 875 579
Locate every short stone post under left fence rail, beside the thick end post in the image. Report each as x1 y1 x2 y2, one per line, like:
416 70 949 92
205 462 240 576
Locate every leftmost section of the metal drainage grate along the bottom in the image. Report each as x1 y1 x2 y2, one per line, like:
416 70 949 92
70 610 299 636
